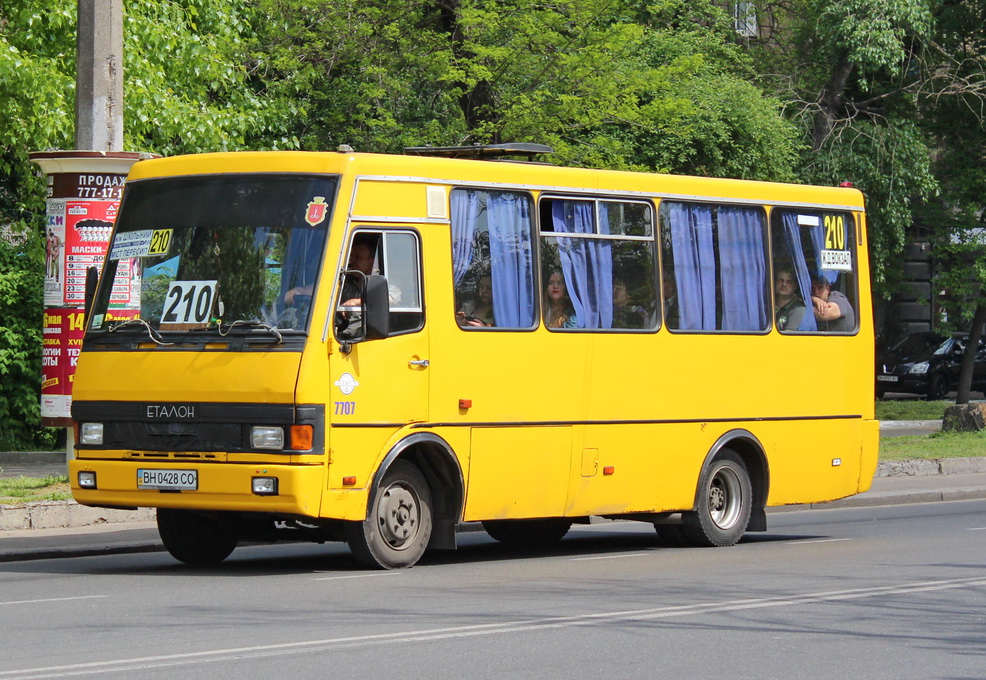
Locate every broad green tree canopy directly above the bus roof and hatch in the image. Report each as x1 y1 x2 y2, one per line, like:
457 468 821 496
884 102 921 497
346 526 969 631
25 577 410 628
254 0 797 179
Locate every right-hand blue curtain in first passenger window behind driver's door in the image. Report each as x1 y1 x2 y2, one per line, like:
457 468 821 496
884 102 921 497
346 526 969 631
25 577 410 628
486 192 535 328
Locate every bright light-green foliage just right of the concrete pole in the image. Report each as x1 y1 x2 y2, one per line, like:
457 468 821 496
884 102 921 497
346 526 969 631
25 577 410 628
124 0 298 155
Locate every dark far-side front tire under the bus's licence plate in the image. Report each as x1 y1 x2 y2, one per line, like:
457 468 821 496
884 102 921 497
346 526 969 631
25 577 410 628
157 508 240 566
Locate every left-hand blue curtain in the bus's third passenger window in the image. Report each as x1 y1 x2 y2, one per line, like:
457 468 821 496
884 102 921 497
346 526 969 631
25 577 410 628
667 203 716 330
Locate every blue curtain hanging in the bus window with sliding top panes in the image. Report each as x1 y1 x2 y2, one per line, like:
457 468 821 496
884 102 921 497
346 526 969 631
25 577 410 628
551 200 613 328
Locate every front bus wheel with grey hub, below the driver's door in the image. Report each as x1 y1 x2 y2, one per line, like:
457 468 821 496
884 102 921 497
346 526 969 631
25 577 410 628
346 460 432 569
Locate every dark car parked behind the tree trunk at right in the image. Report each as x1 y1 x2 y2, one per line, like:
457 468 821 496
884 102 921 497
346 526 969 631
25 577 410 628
876 333 986 399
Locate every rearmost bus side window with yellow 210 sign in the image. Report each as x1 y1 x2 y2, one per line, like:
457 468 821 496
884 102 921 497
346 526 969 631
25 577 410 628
771 208 858 333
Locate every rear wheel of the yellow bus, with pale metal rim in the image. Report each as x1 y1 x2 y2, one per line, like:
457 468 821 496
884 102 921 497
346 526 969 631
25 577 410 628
682 449 753 548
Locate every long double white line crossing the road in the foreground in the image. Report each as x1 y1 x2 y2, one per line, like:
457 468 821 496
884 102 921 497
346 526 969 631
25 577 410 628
0 577 986 680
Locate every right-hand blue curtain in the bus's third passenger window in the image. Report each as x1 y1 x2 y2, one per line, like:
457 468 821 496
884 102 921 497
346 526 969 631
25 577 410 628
718 206 769 331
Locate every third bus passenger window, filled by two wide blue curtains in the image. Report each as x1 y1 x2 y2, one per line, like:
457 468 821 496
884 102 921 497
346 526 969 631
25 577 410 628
660 201 770 331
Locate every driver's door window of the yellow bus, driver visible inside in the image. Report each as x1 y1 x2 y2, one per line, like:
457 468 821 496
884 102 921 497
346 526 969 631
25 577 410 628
336 230 424 340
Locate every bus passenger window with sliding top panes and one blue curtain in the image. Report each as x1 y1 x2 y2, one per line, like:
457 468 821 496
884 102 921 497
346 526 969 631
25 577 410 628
539 197 659 330
